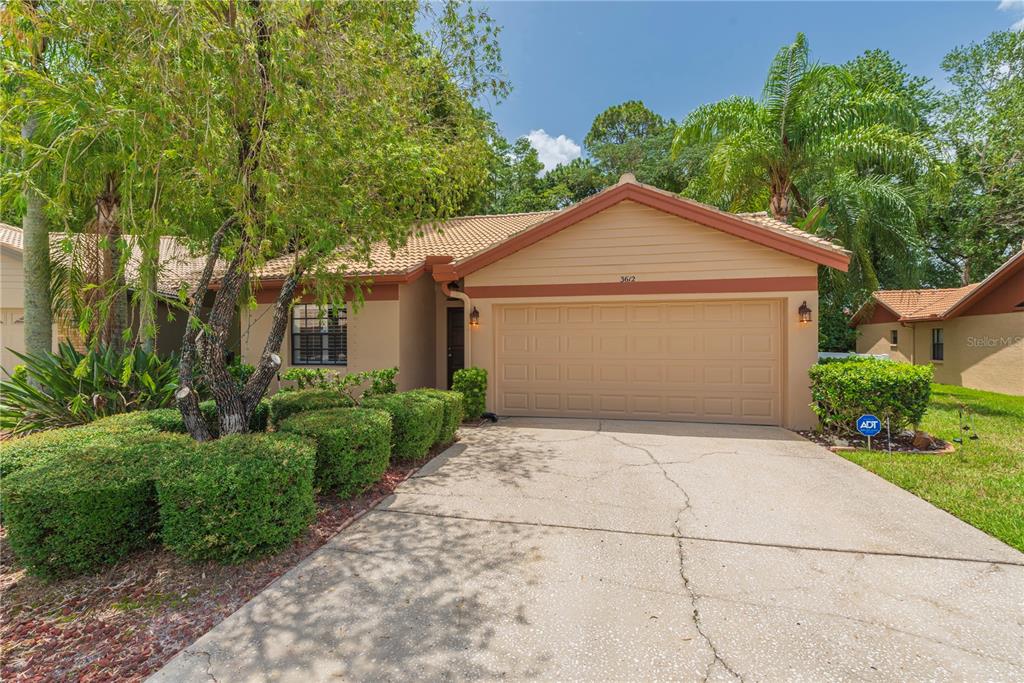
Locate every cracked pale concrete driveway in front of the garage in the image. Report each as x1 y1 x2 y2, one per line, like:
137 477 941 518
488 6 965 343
154 419 1024 682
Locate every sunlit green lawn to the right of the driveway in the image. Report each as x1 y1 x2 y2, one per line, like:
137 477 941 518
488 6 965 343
840 384 1024 551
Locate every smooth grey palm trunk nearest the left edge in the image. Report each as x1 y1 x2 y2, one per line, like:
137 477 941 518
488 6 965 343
22 117 53 353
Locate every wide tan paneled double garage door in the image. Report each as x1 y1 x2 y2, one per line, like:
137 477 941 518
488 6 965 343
495 300 782 425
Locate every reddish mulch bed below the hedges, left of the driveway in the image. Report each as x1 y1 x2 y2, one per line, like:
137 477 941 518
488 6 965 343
0 462 432 682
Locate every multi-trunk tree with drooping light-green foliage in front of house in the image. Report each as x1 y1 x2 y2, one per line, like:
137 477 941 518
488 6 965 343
4 0 507 438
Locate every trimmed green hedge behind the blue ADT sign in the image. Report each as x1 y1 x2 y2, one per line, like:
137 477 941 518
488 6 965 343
808 358 933 434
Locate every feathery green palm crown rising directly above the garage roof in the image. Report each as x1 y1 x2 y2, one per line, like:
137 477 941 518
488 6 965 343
673 34 927 220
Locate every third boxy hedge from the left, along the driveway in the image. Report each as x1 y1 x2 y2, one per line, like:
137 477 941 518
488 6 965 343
278 408 391 498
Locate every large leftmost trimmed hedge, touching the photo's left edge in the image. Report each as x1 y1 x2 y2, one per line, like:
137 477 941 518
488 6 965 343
3 436 195 579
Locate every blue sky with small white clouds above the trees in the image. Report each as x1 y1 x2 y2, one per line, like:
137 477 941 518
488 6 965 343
483 0 1024 166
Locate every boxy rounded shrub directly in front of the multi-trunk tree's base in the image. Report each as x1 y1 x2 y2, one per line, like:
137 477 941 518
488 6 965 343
157 434 316 563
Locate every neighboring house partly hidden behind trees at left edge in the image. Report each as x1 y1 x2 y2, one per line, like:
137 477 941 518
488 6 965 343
0 223 216 370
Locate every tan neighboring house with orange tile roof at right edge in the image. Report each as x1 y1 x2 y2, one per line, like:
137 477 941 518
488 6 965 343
850 251 1024 395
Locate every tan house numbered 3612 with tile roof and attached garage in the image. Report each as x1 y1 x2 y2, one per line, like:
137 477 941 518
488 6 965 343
241 175 849 428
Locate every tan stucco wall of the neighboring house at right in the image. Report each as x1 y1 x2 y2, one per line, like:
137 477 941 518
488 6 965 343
857 311 1024 395
